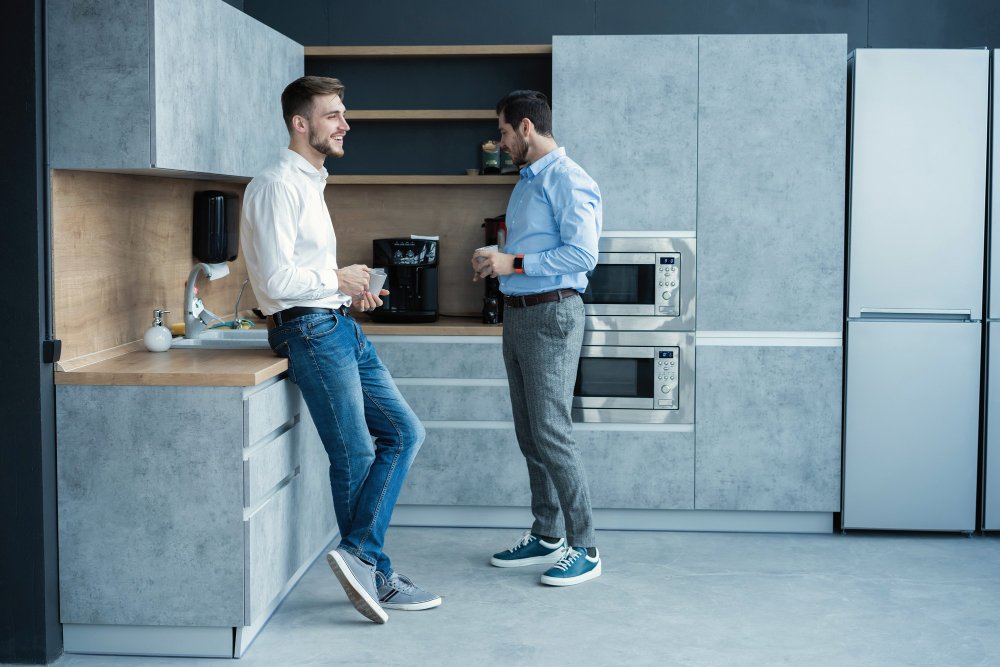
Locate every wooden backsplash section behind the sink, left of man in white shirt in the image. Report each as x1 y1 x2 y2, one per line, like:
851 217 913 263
52 170 256 361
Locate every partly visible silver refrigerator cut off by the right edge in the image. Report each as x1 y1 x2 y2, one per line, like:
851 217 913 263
980 50 1000 530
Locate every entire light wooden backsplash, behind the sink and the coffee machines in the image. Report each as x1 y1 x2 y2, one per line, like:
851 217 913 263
52 170 512 361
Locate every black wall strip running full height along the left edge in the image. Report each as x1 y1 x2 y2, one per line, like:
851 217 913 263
0 0 62 663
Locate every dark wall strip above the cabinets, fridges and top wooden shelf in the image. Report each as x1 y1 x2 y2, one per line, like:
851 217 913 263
240 0 1000 49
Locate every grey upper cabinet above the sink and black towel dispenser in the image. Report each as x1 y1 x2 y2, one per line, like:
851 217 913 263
46 0 304 177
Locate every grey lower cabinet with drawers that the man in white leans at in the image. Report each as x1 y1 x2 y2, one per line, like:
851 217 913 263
57 380 336 657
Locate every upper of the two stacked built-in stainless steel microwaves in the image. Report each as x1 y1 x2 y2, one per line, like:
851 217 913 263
583 235 696 331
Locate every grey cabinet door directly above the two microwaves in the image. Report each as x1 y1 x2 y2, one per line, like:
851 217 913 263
552 35 698 231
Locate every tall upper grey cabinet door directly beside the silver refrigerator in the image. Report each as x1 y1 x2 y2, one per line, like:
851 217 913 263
696 35 847 331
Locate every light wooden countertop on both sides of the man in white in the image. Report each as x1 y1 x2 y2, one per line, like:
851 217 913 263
55 317 503 387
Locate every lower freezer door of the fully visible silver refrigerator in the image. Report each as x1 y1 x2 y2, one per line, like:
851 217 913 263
842 321 982 531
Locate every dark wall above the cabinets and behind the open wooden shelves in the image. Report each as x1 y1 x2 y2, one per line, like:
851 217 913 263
242 0 1000 174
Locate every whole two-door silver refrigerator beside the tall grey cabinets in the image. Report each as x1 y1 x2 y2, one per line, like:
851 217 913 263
841 49 990 531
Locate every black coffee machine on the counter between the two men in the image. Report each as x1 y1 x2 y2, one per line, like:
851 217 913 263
368 238 438 322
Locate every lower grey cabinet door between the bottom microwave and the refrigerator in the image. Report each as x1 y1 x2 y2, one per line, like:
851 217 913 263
695 345 843 512
